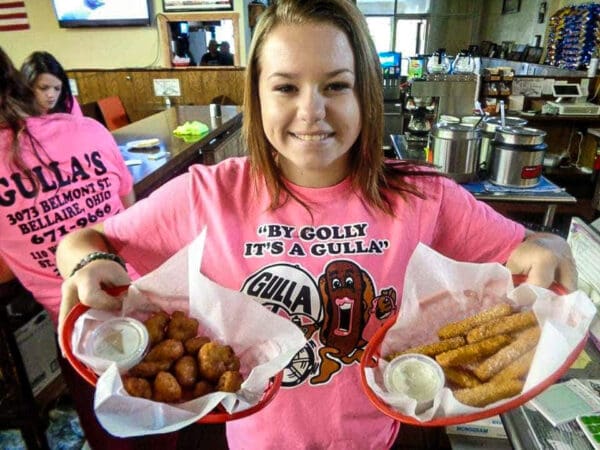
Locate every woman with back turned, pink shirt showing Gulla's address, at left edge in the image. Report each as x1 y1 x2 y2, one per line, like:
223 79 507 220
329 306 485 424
0 48 176 450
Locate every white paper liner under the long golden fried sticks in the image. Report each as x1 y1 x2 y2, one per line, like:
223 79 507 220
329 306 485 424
365 244 596 422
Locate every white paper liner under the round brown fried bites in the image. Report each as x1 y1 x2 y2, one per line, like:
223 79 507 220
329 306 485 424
71 230 306 437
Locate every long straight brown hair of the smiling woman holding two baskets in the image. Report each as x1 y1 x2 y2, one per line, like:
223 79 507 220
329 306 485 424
242 0 430 214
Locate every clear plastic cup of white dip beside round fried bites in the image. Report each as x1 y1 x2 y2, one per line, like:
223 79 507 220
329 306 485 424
84 317 150 375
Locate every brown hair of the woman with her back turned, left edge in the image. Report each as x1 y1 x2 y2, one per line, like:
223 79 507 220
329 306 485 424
0 47 41 187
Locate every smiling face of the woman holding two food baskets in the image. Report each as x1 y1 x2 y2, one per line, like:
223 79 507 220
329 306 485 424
258 23 361 187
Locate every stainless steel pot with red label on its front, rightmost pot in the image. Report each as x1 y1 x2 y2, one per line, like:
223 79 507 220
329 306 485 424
489 127 548 188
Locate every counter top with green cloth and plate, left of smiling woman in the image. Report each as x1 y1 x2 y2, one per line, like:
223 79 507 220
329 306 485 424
112 105 242 198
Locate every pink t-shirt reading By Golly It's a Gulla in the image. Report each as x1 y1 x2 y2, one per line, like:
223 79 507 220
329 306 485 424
105 158 524 450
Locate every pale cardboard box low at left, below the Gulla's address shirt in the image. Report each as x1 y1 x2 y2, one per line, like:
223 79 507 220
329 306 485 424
15 311 60 396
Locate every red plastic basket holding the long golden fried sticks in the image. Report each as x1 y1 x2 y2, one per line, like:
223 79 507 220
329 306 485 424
360 275 588 427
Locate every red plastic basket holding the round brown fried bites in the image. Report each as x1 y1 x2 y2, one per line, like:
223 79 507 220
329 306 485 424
60 287 283 423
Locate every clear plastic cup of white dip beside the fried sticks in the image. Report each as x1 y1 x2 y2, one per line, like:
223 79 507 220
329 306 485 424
383 353 445 414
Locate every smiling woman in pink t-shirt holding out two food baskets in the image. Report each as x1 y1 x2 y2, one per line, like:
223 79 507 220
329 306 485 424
57 0 575 450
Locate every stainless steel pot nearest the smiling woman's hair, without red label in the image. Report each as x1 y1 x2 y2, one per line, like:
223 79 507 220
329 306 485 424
431 123 481 183
